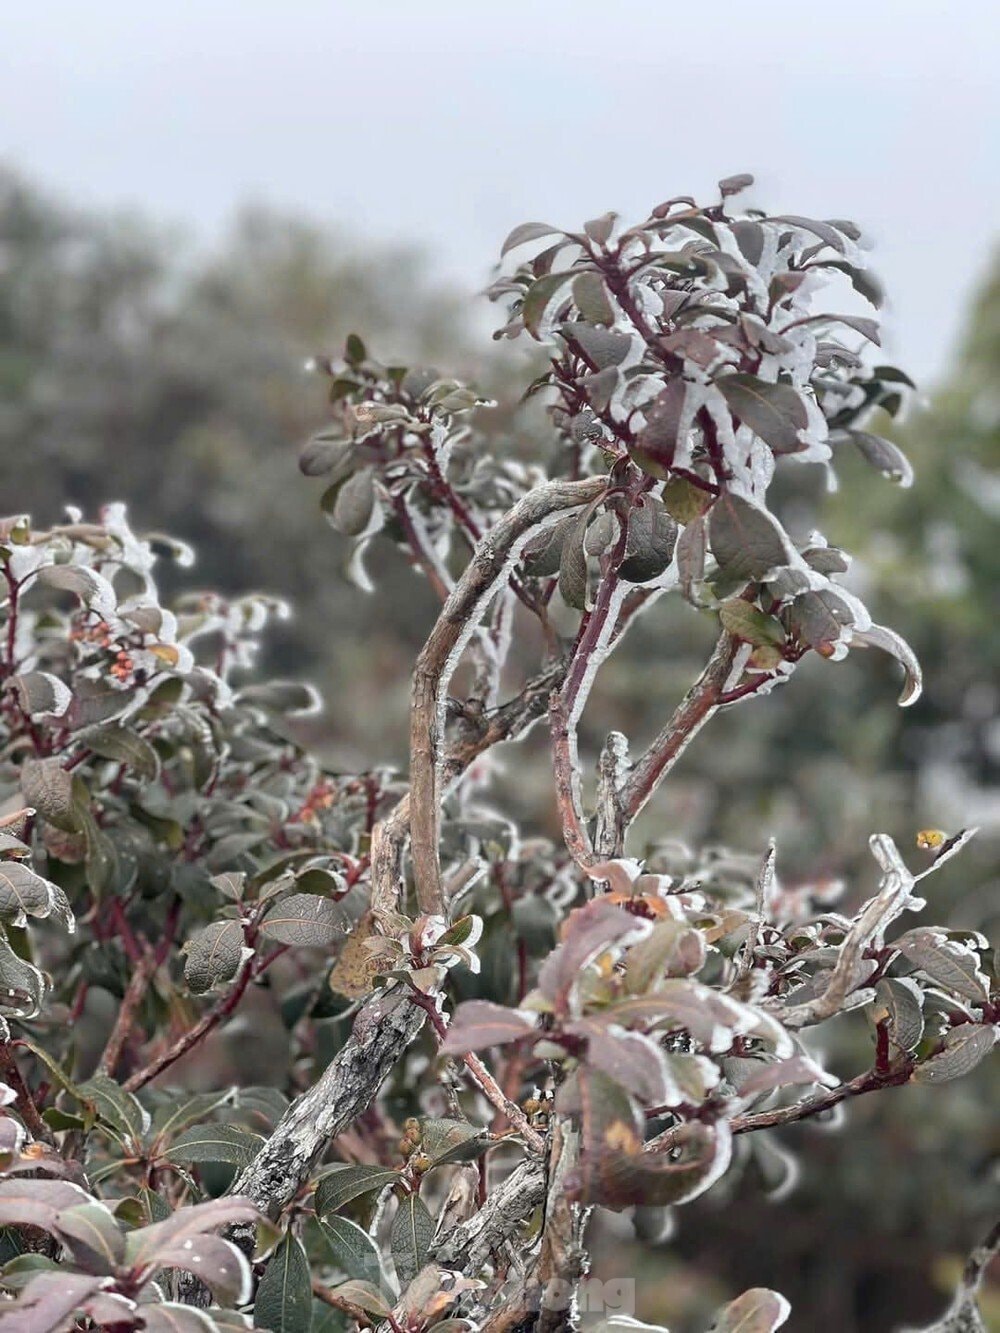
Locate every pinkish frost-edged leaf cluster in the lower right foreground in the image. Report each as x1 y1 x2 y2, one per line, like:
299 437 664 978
443 836 1000 1225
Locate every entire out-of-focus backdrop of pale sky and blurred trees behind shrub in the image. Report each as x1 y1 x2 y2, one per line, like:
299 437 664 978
0 0 1000 1333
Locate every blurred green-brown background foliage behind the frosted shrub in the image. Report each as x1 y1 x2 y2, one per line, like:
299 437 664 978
0 169 1000 1333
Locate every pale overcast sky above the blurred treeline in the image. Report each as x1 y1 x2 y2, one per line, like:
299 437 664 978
0 0 1000 380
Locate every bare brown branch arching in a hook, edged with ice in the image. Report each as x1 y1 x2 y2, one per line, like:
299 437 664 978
409 477 607 914
